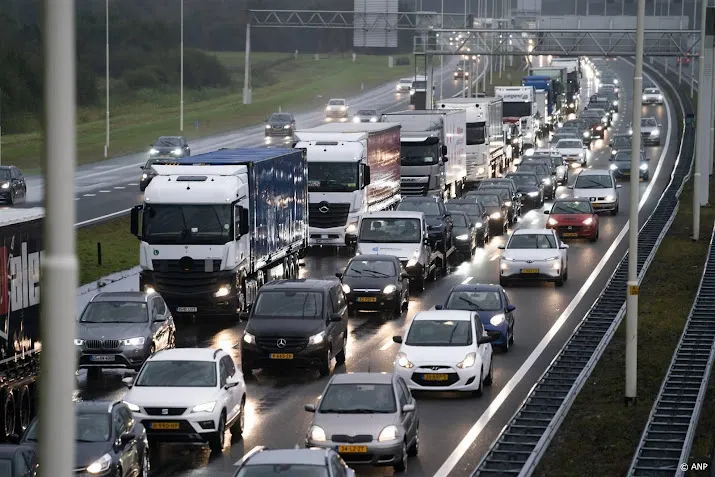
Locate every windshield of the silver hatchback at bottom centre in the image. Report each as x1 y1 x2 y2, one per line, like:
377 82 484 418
318 383 397 414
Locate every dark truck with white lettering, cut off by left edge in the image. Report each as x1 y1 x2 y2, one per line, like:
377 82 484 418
0 207 44 442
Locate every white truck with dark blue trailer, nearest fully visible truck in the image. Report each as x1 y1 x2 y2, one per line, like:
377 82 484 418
131 148 308 319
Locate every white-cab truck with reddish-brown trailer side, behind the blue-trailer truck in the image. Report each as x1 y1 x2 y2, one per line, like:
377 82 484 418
295 123 401 247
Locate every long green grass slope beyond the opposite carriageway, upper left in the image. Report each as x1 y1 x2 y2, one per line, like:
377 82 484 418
3 53 414 173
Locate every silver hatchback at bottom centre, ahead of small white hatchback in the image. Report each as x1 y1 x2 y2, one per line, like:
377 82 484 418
305 373 420 472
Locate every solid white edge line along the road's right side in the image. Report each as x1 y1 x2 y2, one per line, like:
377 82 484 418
434 61 677 477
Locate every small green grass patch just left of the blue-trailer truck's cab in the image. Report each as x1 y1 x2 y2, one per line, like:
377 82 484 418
77 217 139 285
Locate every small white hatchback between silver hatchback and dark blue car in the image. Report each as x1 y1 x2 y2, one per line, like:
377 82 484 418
392 310 500 396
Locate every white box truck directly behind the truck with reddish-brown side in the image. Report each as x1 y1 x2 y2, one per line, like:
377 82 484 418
382 110 467 199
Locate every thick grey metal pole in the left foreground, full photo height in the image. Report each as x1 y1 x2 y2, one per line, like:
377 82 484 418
37 0 78 477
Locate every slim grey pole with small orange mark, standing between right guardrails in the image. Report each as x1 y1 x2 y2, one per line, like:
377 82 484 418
625 0 645 406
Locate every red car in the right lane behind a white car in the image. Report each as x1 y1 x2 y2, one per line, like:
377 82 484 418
544 198 598 242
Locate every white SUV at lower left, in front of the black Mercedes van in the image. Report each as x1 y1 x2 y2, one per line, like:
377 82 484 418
123 348 246 452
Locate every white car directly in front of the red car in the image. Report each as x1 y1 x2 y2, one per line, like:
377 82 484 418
499 229 569 287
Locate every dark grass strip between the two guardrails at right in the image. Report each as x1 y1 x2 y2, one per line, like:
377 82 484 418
534 175 715 477
